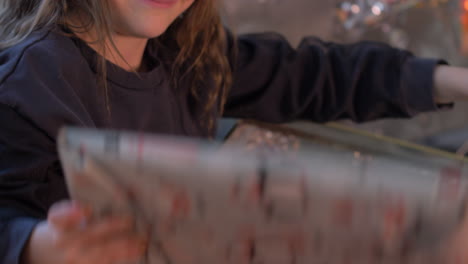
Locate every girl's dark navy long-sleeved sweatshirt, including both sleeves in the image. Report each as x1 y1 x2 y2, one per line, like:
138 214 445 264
0 25 442 264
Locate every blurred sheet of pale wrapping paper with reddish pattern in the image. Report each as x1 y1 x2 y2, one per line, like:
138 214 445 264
59 124 467 264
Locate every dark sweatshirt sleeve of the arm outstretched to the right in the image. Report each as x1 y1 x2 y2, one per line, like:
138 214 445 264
225 33 445 122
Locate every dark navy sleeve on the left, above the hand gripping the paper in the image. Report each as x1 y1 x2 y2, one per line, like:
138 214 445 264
0 30 94 264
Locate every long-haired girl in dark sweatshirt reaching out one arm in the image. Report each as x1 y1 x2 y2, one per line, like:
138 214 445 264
0 0 468 264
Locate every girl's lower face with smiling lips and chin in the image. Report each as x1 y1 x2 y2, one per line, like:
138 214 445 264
109 0 195 39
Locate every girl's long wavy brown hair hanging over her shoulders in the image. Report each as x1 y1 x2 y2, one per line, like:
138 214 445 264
0 0 232 132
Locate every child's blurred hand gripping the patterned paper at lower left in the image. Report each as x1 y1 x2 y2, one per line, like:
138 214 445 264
23 202 147 264
